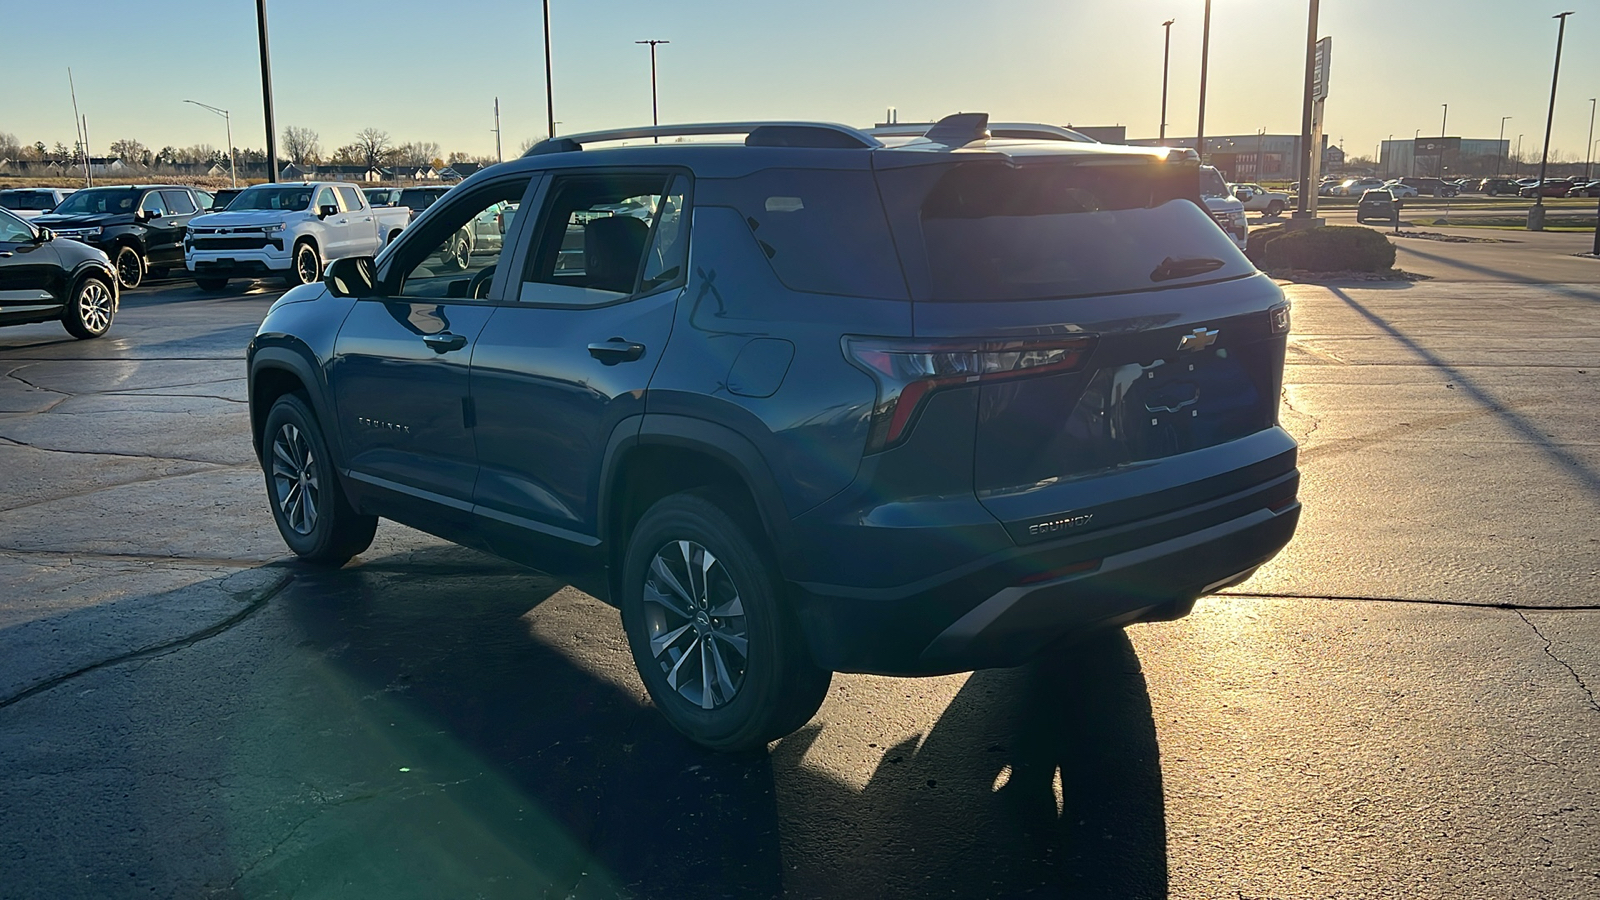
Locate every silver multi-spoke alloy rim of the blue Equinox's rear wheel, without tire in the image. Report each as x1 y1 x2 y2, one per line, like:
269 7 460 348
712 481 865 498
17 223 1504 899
643 541 750 709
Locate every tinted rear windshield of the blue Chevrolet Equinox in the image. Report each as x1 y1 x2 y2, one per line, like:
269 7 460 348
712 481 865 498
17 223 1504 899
902 162 1254 301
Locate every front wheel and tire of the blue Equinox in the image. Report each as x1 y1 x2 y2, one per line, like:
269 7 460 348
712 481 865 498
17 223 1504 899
261 394 378 567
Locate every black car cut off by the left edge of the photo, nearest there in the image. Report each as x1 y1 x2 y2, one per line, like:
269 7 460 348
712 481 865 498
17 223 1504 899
0 210 117 340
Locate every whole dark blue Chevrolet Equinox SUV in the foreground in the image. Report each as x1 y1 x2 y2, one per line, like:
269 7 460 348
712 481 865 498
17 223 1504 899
248 115 1299 749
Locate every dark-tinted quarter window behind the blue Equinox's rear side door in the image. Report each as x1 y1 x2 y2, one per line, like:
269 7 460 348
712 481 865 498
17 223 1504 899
698 168 906 299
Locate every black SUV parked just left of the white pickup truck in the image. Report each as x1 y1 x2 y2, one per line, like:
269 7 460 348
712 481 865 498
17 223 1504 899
34 184 202 290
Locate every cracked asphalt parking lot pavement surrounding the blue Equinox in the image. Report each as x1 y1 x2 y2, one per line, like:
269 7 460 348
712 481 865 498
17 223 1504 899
0 248 1600 900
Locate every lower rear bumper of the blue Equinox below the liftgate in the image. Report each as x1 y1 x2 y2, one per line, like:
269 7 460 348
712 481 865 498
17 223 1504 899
794 471 1301 674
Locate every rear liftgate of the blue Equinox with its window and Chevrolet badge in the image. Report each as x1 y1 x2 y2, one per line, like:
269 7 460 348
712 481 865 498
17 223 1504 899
870 149 1294 544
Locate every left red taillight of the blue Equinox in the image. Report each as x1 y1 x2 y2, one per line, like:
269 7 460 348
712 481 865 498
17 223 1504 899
845 335 1094 453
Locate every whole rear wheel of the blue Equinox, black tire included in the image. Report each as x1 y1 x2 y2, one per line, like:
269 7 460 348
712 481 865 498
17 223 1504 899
621 492 834 751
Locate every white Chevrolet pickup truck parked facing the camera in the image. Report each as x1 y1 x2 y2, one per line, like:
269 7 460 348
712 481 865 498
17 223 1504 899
184 181 411 291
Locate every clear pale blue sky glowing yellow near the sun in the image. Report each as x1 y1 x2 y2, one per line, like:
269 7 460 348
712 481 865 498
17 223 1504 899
9 0 1600 159
